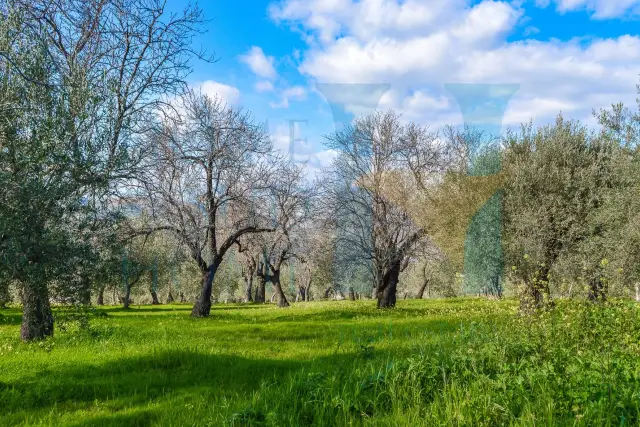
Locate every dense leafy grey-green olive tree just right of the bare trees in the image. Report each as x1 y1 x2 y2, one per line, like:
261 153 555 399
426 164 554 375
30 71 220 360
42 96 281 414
504 115 616 309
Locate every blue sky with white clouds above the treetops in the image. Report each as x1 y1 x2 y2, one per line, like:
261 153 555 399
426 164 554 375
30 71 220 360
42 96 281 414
169 0 640 176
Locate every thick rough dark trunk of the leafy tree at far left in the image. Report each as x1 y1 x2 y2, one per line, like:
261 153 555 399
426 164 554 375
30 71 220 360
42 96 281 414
20 285 53 341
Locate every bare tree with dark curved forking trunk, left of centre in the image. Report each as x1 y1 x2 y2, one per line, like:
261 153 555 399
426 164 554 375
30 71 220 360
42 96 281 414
137 91 298 317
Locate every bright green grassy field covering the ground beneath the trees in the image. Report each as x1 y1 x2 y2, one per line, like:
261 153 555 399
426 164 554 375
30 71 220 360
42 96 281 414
0 299 640 426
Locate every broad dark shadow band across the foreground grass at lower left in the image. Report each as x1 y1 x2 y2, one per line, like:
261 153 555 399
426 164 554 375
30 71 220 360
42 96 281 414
0 351 383 418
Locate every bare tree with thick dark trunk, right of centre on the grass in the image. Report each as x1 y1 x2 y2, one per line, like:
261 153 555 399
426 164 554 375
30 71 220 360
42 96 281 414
323 111 441 308
